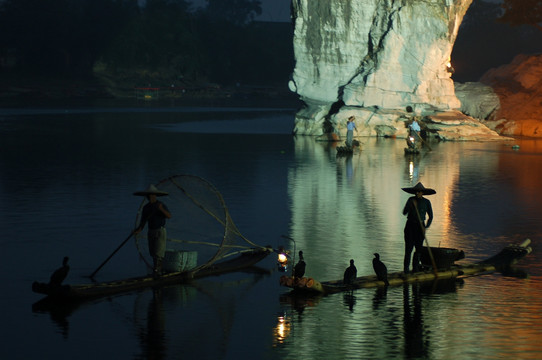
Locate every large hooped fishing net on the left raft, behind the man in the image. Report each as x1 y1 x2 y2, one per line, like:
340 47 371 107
132 175 264 271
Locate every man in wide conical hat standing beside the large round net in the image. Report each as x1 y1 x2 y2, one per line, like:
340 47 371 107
134 184 171 276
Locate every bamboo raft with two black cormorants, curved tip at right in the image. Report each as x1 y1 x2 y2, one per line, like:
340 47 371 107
280 239 532 294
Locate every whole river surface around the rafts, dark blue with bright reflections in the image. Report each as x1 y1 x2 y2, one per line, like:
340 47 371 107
0 102 542 359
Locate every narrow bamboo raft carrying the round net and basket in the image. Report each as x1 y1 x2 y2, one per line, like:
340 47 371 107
32 248 273 301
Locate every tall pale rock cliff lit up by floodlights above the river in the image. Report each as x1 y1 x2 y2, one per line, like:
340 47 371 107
289 0 502 140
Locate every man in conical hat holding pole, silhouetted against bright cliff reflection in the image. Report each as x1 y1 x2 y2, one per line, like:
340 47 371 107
401 182 437 274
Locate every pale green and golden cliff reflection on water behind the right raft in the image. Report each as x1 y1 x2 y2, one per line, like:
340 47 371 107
288 137 468 280
